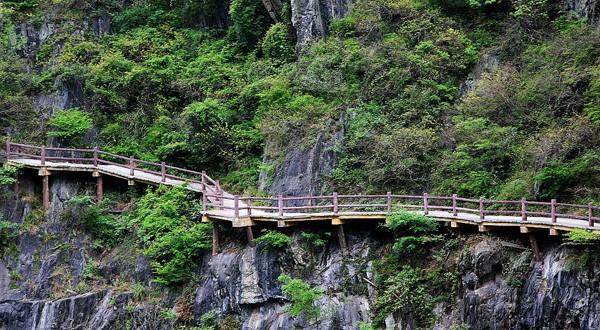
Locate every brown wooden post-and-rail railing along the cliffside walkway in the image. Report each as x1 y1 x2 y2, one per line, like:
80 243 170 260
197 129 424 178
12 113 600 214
4 142 600 228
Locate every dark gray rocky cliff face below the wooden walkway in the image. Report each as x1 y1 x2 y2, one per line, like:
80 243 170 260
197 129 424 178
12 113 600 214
0 177 600 330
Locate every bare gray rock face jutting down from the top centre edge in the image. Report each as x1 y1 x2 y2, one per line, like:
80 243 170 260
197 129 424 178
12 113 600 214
291 0 354 51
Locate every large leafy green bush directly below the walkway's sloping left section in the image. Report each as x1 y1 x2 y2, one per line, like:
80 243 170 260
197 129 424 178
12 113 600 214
128 186 212 285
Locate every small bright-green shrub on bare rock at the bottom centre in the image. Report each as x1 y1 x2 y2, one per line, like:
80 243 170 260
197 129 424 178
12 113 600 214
277 274 323 320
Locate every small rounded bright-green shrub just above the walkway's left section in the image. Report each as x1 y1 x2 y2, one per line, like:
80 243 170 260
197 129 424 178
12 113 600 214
48 108 93 139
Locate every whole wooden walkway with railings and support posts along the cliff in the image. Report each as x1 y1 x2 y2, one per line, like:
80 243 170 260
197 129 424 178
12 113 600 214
0 142 600 253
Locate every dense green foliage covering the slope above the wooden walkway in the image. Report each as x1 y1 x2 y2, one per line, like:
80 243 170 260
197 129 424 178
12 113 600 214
0 0 600 202
